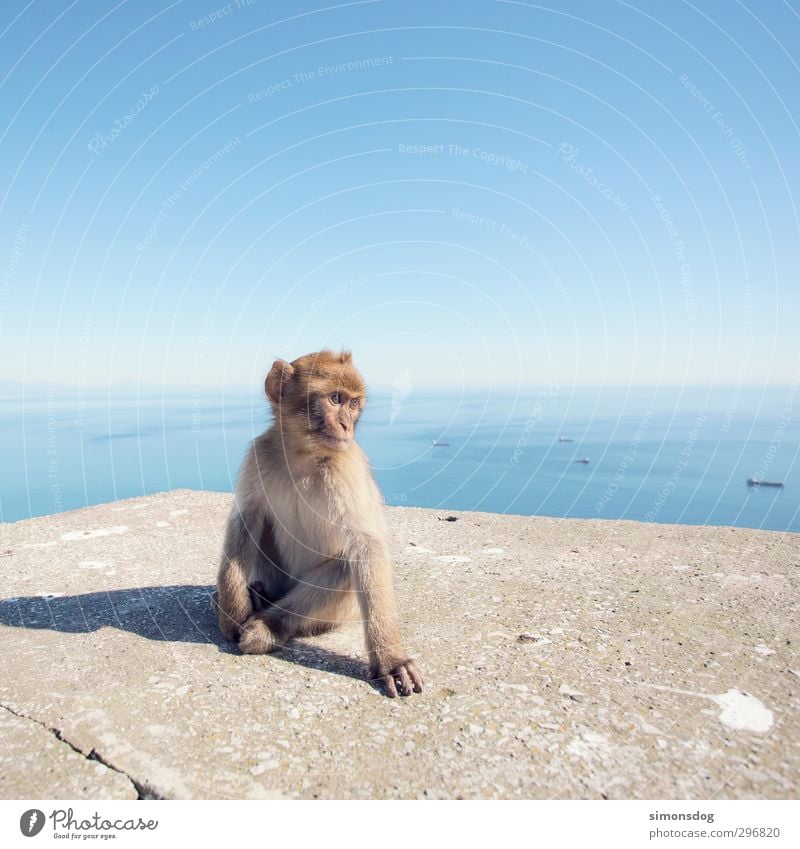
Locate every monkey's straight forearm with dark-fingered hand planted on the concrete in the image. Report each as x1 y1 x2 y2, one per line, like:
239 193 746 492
345 535 423 698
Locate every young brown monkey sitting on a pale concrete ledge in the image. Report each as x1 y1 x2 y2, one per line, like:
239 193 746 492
217 351 422 697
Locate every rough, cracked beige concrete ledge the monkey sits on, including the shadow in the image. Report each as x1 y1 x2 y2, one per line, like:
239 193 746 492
0 491 800 798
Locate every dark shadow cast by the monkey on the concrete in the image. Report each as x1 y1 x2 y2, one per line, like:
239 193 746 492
0 584 368 681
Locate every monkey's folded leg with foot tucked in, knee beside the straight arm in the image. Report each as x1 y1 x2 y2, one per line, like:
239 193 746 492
239 558 352 654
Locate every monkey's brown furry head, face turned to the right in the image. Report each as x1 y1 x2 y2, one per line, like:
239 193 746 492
264 351 366 455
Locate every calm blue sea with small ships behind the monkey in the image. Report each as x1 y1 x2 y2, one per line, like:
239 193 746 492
0 387 800 531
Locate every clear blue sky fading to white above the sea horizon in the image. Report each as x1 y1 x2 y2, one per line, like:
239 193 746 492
0 0 800 390
